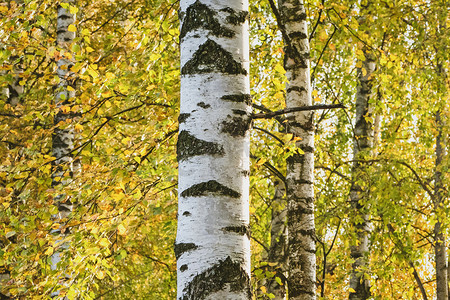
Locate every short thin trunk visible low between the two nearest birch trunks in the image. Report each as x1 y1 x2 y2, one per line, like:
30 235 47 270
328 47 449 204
267 180 288 300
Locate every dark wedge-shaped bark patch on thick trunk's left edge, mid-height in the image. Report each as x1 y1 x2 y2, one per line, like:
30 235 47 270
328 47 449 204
177 130 225 161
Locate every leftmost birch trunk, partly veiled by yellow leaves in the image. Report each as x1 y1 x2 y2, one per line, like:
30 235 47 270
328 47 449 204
51 1 76 297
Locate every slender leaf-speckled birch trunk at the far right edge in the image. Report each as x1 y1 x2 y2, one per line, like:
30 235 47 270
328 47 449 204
434 111 448 300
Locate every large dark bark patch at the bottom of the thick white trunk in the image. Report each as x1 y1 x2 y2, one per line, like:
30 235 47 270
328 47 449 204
179 256 252 300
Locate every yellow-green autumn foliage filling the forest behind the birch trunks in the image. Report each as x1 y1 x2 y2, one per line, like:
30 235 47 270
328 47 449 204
0 0 450 299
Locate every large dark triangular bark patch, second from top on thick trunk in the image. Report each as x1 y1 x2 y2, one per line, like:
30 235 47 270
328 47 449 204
181 40 247 75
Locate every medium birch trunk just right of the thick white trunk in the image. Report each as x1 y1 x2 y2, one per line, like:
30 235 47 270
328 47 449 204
278 0 316 300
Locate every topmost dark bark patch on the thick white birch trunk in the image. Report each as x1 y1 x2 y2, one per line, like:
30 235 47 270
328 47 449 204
180 1 235 39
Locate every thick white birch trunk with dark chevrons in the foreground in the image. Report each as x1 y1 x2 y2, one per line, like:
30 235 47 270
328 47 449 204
175 0 252 300
